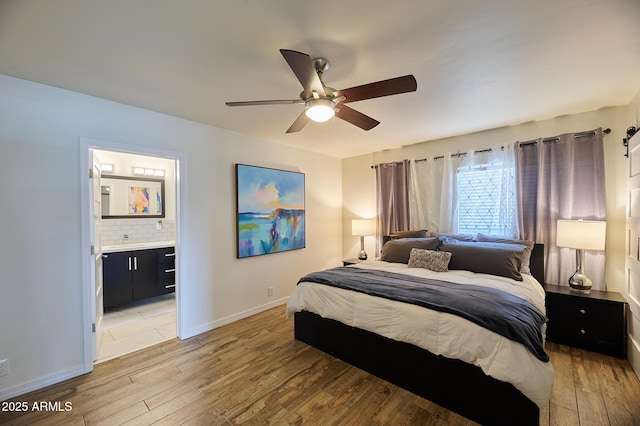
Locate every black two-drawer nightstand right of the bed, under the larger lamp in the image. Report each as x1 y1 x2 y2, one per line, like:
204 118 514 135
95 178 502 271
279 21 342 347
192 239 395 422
544 284 629 359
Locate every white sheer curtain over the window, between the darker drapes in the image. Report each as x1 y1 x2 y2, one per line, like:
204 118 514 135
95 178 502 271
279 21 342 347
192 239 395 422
409 144 519 237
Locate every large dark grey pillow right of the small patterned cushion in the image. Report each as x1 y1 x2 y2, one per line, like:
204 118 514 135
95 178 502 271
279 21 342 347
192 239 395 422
440 242 526 281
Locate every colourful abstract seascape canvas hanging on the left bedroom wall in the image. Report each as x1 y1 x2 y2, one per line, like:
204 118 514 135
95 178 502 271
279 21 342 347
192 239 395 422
236 164 305 258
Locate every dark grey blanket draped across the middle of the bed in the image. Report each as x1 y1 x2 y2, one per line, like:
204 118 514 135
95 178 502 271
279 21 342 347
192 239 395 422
298 267 549 362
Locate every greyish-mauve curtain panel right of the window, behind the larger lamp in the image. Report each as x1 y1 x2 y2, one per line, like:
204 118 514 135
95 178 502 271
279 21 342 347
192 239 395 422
518 129 606 290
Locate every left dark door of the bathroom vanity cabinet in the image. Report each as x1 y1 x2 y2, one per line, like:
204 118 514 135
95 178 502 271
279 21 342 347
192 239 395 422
102 252 133 308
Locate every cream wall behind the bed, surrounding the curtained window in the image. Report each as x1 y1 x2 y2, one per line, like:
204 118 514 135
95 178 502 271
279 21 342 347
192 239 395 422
342 106 635 291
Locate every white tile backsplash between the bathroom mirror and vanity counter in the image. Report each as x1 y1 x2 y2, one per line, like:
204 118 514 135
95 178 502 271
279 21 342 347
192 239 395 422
102 219 176 246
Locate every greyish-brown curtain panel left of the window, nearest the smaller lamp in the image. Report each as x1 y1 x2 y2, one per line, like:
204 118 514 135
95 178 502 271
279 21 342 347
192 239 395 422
376 160 409 256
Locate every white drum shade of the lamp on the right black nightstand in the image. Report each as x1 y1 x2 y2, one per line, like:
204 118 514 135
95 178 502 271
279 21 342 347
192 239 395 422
556 220 607 250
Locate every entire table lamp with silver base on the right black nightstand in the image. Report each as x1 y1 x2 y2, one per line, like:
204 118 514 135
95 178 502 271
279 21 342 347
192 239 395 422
556 219 607 292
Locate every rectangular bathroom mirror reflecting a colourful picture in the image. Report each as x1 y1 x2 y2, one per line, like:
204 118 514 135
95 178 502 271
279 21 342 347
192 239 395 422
100 176 164 219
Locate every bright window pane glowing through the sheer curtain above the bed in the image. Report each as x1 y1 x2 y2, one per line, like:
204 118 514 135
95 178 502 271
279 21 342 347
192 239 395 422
456 162 518 237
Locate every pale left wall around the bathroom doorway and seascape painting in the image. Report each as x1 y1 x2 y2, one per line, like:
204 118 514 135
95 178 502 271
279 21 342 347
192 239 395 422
0 75 342 400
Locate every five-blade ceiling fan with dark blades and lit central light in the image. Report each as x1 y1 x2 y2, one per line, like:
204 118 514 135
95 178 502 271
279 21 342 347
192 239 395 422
226 49 417 133
